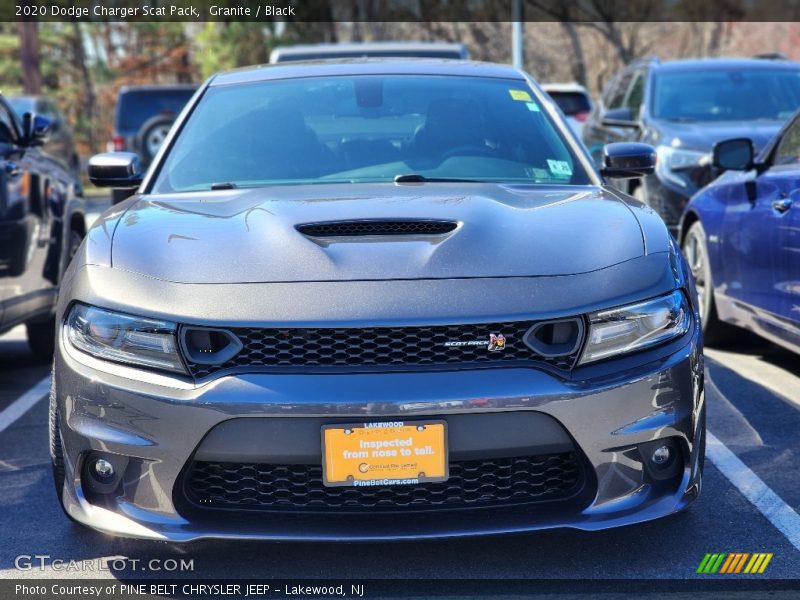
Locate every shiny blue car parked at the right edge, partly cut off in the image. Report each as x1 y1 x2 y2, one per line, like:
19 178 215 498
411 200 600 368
680 112 800 352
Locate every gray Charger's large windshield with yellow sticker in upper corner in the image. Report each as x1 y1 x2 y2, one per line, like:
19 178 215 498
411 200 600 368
153 75 590 193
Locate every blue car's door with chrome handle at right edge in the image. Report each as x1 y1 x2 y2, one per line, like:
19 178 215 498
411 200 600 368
722 117 800 343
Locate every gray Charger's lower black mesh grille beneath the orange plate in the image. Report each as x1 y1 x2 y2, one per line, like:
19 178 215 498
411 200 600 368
184 452 584 512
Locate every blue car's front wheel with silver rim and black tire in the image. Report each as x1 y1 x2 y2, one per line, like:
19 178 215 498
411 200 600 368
682 221 736 346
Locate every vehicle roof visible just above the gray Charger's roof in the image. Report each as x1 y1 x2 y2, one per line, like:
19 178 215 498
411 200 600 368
269 42 469 63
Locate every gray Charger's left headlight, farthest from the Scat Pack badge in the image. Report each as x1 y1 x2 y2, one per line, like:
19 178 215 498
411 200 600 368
66 304 186 373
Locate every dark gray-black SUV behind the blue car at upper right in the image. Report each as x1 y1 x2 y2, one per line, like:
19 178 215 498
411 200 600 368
582 57 800 233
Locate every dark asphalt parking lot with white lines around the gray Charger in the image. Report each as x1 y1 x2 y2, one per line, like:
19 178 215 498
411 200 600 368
0 198 800 597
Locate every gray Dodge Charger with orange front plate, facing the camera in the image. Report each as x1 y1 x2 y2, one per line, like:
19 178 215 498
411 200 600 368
50 60 705 542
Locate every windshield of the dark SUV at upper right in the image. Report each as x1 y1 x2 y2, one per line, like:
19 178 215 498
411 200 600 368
653 68 800 121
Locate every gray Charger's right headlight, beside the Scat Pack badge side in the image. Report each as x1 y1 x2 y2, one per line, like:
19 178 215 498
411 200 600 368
580 290 691 364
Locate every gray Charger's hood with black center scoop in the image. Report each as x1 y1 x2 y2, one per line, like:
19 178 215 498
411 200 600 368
111 183 644 284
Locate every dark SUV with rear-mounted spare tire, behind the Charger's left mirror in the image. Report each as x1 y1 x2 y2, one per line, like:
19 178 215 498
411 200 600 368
108 84 197 169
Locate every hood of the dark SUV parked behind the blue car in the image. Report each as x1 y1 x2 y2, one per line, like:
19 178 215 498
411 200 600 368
660 121 783 152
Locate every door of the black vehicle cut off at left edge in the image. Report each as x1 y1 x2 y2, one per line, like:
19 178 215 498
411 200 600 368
0 100 53 325
